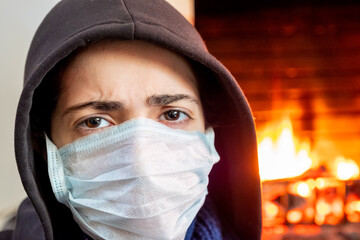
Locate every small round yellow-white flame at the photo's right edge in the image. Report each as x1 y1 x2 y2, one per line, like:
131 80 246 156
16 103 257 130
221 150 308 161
335 157 359 181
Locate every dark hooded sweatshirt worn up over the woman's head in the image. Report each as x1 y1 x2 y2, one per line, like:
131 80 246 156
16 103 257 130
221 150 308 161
0 0 261 240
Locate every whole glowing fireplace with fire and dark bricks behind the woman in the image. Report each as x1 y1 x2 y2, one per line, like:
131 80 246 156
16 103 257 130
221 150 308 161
195 1 360 240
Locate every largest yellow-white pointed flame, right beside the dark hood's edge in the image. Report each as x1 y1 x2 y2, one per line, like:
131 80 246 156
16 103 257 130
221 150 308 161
258 120 312 181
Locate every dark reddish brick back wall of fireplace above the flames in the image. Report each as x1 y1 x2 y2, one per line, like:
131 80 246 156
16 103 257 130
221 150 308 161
196 4 360 163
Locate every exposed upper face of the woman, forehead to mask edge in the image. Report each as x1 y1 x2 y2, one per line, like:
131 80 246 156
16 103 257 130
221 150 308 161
51 41 205 148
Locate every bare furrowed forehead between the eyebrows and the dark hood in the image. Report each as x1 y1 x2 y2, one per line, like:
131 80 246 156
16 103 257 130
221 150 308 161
61 40 198 103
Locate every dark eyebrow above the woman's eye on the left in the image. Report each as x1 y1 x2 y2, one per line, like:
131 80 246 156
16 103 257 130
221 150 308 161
63 101 124 115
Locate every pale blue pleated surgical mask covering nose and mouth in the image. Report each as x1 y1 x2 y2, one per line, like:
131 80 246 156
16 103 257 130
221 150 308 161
46 118 219 240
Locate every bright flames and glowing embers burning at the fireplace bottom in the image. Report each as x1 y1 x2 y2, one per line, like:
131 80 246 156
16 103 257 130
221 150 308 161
258 116 360 238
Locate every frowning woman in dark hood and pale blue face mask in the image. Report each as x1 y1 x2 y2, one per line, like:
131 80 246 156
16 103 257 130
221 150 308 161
2 0 261 239
